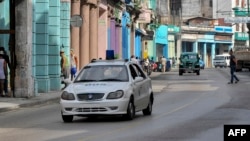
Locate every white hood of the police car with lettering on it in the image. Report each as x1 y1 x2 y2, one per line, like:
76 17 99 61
65 82 129 93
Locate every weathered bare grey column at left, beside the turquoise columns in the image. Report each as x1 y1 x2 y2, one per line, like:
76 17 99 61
14 0 34 97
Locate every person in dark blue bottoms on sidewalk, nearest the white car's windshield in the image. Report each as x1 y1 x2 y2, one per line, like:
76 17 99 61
70 49 78 81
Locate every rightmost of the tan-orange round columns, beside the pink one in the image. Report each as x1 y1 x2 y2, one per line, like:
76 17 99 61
89 2 99 60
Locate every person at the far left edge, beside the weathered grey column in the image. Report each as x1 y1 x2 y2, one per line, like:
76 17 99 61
0 51 8 97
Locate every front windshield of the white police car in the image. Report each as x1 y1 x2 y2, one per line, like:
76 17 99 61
74 65 128 82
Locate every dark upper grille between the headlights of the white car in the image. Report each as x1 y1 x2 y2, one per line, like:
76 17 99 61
77 93 104 101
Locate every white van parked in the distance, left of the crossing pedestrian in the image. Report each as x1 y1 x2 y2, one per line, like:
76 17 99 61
213 54 230 68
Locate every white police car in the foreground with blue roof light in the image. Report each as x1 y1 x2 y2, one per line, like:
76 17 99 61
60 60 154 122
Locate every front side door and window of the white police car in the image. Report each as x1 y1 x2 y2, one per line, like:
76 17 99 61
129 64 143 110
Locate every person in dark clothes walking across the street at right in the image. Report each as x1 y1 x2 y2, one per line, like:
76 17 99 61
228 49 240 84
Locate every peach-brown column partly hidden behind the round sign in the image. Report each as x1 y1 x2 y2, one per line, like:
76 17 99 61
70 0 79 70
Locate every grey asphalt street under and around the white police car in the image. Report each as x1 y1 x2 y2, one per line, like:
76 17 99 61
0 68 250 141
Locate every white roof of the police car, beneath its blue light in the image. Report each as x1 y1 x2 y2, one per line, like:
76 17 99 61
87 59 132 66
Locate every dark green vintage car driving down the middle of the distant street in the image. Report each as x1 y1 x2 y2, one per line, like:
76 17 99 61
179 52 200 75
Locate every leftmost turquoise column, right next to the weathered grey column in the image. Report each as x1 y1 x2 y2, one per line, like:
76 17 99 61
34 0 50 93
